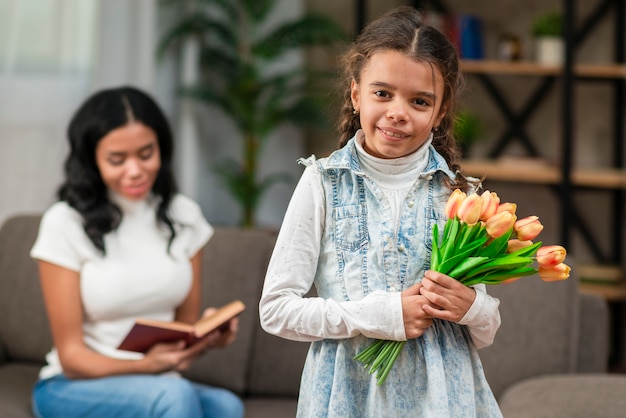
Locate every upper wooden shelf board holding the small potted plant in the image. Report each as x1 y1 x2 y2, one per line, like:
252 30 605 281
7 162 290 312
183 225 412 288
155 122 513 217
461 60 626 79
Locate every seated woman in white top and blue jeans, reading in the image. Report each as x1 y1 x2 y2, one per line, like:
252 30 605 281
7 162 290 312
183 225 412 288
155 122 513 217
31 87 243 418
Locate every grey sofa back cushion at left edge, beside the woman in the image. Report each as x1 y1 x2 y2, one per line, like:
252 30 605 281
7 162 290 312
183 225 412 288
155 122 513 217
0 215 52 363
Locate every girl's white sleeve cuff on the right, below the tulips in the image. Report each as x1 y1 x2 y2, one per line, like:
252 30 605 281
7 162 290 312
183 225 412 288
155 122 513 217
459 284 501 348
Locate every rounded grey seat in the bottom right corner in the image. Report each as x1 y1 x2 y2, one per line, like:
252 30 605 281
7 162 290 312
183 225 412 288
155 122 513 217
500 374 626 418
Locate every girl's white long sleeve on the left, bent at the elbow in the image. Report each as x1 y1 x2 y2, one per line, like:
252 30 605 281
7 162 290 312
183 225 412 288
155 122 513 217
259 165 406 341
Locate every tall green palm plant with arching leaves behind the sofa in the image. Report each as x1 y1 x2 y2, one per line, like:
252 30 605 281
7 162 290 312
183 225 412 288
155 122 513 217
159 0 347 227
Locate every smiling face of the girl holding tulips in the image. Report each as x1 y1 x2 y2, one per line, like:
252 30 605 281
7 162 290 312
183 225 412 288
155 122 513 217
351 50 445 158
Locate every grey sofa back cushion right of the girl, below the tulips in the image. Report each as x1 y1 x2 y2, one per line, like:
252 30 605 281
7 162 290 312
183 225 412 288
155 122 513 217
479 276 579 398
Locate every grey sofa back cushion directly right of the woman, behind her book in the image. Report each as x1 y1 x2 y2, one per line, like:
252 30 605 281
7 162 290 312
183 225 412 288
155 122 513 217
185 228 275 394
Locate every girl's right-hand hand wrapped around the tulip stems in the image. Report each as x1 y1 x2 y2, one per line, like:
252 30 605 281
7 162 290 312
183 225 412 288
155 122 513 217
420 270 476 322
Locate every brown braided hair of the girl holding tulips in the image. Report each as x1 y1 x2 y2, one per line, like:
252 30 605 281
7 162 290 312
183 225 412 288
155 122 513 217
339 6 468 191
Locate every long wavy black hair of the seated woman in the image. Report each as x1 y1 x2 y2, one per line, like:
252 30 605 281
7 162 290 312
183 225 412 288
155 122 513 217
58 87 177 253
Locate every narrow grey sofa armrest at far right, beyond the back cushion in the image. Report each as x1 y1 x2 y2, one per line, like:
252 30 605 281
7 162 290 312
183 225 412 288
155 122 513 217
576 293 610 373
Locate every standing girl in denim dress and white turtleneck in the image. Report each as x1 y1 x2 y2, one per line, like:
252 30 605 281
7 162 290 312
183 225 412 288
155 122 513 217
260 7 501 418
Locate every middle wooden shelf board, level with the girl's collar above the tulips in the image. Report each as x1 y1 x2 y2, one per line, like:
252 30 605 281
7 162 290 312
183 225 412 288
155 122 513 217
461 158 626 189
